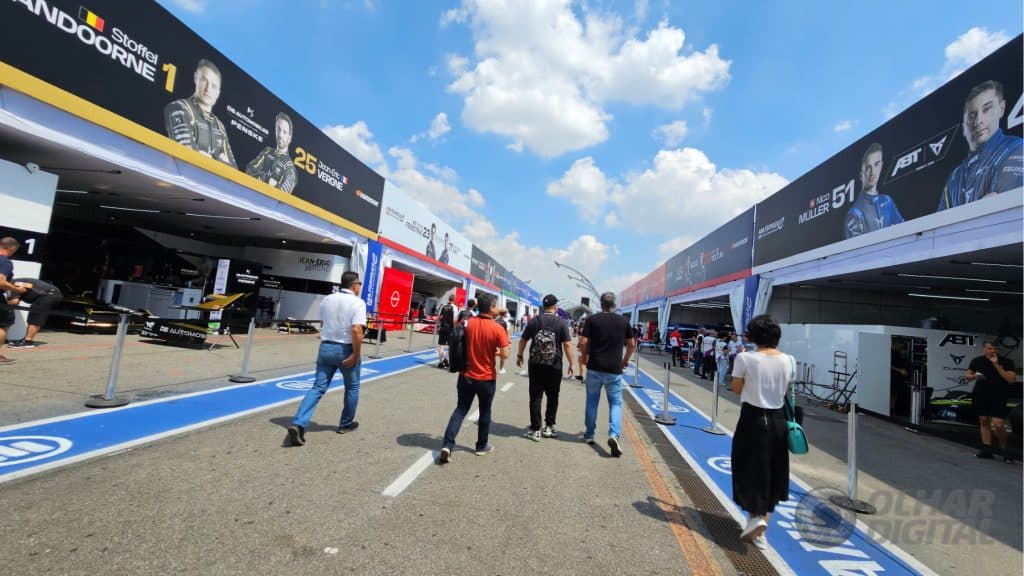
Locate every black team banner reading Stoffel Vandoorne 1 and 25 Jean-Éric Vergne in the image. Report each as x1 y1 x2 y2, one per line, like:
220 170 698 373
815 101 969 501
0 0 384 234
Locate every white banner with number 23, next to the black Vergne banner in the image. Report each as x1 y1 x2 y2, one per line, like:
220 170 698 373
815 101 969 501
380 182 473 274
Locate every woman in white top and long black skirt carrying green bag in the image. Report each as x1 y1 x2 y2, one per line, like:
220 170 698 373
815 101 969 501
732 315 796 548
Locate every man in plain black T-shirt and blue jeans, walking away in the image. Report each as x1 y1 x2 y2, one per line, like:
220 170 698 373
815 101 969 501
580 292 636 458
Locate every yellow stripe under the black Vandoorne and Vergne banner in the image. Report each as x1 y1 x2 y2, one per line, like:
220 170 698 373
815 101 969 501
0 62 377 240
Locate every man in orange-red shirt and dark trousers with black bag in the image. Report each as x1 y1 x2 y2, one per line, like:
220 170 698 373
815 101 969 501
438 294 509 464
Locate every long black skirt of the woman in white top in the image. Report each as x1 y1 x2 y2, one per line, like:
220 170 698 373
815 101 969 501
732 402 790 516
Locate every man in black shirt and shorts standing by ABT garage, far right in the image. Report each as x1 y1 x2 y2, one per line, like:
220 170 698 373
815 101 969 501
964 340 1017 463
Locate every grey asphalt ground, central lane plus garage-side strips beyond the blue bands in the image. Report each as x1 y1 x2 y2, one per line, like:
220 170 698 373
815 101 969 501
0 331 1024 574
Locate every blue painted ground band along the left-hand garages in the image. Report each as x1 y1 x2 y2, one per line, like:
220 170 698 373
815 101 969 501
0 352 437 483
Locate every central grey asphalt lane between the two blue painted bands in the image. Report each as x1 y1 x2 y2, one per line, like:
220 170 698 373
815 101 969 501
0 332 741 575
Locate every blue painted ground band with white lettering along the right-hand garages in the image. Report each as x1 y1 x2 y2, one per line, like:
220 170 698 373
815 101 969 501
624 366 934 576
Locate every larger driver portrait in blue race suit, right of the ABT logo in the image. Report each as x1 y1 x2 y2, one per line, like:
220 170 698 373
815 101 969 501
936 80 1024 210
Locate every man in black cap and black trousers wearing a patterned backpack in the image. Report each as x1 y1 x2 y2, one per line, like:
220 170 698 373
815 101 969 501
516 294 572 442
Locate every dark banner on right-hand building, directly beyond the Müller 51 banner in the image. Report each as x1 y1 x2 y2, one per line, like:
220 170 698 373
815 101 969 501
665 208 754 296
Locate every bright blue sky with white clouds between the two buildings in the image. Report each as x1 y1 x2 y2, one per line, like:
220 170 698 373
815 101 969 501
161 0 1022 299
